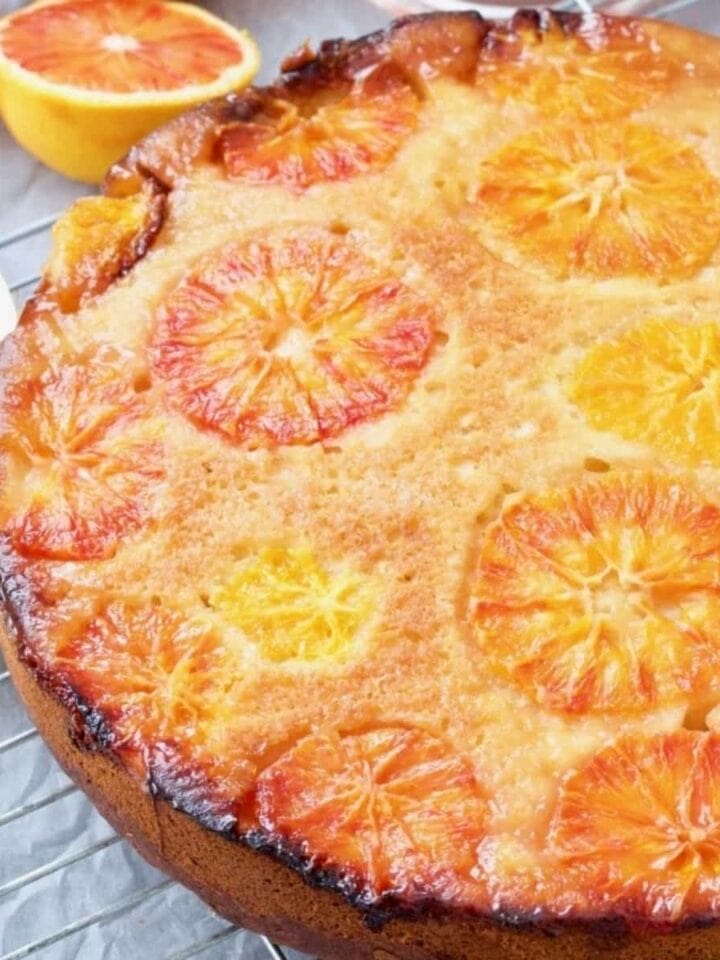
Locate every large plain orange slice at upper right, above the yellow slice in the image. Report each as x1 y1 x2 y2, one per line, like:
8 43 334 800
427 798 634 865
475 123 720 281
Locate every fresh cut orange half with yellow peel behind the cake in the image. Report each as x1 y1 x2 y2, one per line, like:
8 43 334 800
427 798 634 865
0 0 259 182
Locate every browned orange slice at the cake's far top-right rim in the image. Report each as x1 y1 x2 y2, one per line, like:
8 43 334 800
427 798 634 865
477 17 681 121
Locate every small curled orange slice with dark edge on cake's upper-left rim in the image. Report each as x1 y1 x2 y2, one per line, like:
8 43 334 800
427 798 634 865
44 193 164 313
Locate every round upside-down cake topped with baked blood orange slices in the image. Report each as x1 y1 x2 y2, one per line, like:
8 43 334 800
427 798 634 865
0 11 720 960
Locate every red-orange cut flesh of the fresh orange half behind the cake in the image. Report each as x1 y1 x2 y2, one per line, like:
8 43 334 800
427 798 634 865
0 0 243 93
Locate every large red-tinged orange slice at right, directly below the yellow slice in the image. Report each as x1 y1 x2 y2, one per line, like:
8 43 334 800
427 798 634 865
473 473 720 713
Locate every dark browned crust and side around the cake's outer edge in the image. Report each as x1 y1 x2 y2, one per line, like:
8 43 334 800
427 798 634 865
0 9 720 960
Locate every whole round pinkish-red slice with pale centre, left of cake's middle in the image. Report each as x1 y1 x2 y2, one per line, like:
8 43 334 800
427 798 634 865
153 226 434 446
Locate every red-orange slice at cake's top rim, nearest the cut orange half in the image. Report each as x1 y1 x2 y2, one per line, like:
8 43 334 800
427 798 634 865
221 66 419 191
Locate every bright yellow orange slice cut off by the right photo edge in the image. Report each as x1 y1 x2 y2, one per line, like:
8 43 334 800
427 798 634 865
569 320 720 466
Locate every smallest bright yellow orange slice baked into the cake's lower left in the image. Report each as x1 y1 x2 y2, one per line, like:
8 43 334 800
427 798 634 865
210 547 373 662
